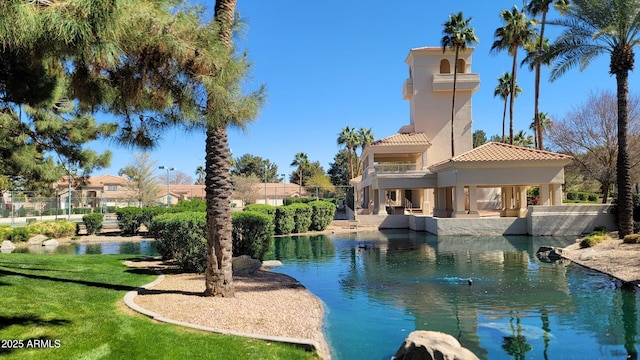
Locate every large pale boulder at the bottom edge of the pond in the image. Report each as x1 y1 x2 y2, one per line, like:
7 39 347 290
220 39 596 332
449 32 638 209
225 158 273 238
393 330 478 360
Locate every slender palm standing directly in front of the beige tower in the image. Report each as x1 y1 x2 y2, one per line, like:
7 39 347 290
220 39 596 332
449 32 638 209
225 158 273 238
440 11 478 157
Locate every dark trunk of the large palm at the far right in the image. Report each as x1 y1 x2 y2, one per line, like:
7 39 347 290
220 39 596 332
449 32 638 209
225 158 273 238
616 71 633 239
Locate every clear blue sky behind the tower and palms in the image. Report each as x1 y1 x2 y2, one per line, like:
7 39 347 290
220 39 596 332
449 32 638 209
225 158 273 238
94 0 624 178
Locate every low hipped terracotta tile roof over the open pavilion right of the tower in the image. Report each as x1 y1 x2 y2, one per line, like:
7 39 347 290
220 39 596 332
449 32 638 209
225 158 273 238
448 142 572 162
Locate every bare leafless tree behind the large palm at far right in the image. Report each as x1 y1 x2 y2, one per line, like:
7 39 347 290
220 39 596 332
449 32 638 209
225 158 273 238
549 91 640 202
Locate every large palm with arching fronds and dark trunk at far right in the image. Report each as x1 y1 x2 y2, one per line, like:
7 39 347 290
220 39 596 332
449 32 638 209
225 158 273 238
541 0 640 238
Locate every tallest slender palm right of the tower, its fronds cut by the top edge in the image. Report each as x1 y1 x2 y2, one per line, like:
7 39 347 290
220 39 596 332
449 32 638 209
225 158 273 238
525 0 569 150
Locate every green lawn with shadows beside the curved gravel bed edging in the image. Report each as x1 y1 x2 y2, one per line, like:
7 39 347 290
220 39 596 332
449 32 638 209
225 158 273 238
0 254 317 359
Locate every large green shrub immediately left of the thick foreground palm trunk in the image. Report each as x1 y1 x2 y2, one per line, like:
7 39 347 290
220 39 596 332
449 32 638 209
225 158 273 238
149 212 207 273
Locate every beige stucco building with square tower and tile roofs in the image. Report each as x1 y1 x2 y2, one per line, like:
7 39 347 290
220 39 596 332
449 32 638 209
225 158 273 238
351 47 600 233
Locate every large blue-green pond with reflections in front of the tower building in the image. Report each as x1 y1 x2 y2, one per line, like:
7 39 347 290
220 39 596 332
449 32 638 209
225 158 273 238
274 231 640 360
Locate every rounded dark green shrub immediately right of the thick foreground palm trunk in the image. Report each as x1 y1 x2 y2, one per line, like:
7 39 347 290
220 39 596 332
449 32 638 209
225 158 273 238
231 211 274 260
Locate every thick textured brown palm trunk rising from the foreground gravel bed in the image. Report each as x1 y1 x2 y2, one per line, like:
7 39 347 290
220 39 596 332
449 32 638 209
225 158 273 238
204 0 236 297
